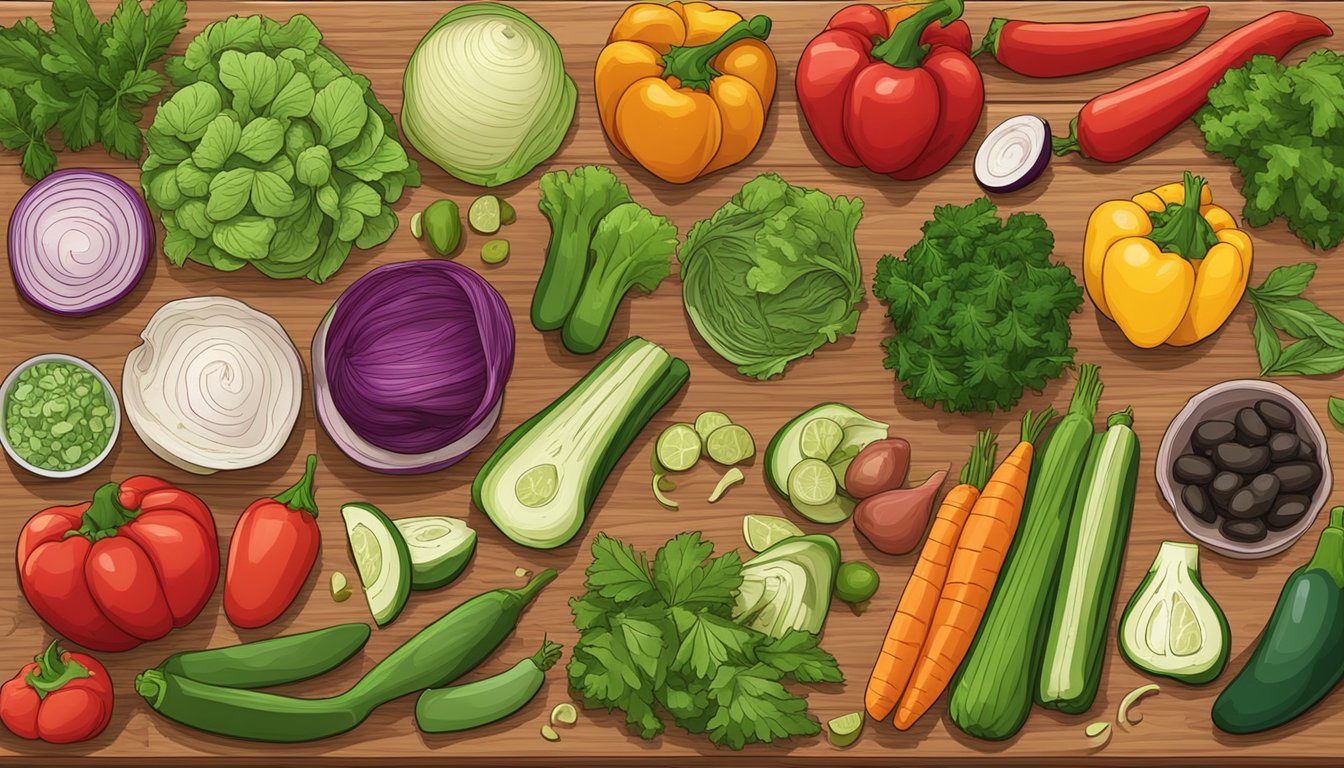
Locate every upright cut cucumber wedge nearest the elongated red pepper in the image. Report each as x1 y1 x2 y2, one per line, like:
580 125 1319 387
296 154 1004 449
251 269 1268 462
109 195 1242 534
340 502 413 627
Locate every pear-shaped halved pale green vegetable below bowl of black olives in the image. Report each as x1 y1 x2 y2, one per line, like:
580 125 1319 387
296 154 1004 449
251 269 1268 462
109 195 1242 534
1120 541 1228 685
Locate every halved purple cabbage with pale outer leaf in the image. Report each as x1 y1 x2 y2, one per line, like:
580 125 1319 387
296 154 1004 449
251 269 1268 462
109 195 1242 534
313 261 513 475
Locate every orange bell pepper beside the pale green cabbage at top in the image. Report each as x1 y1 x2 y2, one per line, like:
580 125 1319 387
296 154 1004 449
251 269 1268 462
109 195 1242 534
594 1 777 184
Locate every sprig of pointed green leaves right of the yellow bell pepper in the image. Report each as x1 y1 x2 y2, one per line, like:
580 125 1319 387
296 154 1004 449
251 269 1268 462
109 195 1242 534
1246 262 1344 377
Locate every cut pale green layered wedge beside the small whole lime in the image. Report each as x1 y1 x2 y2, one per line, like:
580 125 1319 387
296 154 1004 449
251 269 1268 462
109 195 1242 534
732 534 840 638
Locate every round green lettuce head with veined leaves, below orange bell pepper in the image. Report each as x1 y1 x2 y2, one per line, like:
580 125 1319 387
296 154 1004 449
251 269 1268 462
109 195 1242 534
680 174 863 379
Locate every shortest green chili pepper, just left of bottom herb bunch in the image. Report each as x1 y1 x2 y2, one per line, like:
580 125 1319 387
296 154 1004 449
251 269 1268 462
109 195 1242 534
415 638 560 733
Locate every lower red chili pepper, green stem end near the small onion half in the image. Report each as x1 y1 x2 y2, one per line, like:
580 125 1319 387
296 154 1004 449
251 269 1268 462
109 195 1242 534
1054 11 1333 163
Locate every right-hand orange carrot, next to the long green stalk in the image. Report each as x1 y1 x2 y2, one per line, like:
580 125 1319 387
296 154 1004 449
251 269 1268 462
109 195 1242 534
894 408 1055 730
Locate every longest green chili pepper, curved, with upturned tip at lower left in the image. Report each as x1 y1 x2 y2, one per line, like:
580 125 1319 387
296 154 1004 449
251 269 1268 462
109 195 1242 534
136 569 555 742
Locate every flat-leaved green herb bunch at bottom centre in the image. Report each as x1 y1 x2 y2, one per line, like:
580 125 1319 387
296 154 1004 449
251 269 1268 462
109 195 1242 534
569 533 844 749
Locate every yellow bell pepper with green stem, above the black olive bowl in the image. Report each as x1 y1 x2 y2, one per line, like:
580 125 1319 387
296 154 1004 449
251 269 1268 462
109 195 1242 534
1083 171 1253 347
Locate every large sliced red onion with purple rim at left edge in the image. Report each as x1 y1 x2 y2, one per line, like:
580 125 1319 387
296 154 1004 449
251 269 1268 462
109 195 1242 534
9 168 155 315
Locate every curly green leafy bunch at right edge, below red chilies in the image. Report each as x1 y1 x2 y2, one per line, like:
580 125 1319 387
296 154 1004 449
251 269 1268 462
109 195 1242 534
1195 50 1344 249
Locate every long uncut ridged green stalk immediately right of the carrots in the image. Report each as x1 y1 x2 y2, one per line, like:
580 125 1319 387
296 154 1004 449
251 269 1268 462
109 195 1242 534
949 364 1102 740
